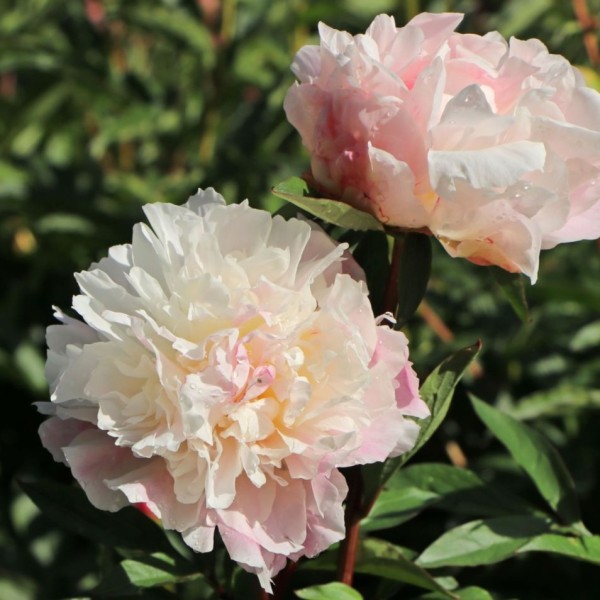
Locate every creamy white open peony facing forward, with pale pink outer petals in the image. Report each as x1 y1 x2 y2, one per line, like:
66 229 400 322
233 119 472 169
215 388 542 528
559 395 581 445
40 189 428 590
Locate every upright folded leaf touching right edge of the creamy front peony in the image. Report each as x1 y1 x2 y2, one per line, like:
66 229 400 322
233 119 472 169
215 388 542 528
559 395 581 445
361 342 481 506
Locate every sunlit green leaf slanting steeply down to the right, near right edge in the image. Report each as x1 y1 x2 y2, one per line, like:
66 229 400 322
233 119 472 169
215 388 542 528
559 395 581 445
471 397 582 528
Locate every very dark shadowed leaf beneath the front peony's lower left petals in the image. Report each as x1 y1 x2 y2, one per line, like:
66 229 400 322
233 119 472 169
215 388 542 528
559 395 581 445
20 481 174 554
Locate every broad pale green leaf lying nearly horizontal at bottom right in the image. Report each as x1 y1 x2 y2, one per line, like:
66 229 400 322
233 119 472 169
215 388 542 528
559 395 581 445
416 516 550 568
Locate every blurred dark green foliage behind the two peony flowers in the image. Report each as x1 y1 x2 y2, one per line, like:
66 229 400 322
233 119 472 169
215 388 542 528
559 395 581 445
0 0 600 600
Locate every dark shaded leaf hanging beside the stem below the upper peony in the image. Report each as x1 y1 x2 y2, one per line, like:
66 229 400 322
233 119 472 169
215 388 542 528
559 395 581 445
394 233 431 329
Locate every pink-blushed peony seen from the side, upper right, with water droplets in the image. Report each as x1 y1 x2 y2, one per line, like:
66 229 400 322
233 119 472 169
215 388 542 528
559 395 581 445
285 13 600 282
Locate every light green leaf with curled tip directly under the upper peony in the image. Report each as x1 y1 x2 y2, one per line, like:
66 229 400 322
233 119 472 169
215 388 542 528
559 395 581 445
272 177 383 231
